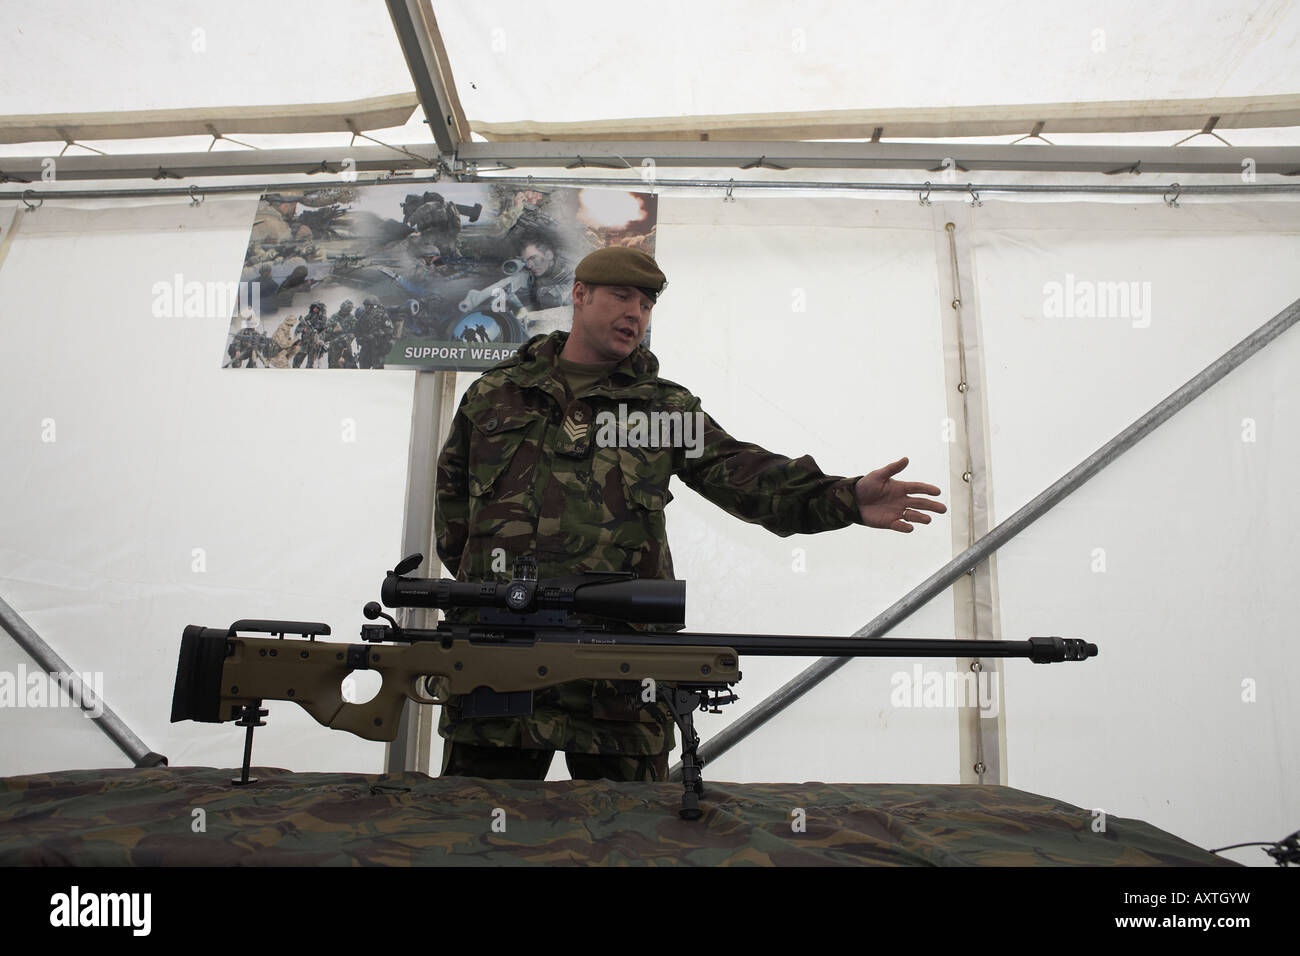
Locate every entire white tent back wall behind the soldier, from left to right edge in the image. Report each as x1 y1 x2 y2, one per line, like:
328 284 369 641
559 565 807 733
0 195 1300 863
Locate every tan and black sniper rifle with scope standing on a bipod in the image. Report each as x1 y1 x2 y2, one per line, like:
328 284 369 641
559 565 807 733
172 554 1097 819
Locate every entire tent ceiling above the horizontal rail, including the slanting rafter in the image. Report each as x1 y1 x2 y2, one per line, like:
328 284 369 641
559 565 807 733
0 0 1300 178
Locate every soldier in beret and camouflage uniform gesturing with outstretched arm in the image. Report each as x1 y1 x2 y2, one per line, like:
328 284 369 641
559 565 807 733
434 247 946 780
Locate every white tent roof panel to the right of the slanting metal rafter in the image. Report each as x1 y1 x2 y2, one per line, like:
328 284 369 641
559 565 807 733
433 0 1300 123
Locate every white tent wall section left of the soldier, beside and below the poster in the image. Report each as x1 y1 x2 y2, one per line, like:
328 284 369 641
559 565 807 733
0 198 413 774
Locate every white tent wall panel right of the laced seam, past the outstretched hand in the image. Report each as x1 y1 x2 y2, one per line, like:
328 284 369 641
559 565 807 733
971 203 1300 864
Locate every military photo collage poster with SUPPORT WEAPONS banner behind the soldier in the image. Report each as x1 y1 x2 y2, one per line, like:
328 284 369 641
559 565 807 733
222 183 658 371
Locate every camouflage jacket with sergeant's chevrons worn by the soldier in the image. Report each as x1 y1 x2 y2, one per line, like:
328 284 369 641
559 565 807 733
434 332 861 754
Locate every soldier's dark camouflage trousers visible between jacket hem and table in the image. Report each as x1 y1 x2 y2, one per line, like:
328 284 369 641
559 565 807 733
442 740 668 783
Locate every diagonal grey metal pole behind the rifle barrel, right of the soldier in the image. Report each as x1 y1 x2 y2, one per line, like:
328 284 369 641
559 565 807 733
670 299 1300 779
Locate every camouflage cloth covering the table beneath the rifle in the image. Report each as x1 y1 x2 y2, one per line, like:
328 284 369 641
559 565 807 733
0 767 1235 866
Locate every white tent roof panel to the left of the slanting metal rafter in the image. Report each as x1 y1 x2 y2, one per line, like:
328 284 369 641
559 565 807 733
0 0 415 116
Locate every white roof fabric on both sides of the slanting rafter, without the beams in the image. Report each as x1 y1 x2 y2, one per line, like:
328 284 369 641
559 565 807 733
0 0 1300 156
